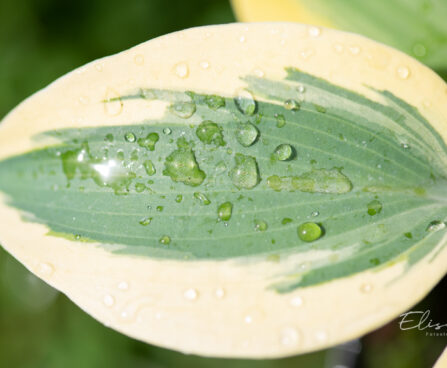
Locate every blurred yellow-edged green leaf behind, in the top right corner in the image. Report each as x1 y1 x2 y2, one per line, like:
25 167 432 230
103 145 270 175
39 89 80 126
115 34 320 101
233 0 447 75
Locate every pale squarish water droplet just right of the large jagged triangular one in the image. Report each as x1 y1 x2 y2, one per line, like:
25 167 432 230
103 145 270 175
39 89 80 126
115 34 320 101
228 153 260 189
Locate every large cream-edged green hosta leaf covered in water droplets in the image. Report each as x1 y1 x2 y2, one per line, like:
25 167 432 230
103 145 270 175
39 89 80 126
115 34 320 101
0 24 447 357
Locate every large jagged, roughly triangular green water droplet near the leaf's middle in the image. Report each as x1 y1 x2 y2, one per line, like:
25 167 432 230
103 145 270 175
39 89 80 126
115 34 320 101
163 137 206 187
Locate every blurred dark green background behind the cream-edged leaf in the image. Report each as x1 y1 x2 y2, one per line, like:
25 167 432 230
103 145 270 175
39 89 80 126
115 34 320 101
0 0 447 368
